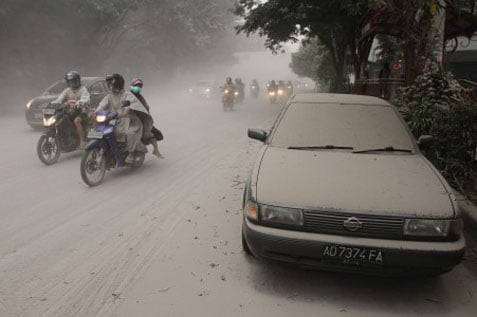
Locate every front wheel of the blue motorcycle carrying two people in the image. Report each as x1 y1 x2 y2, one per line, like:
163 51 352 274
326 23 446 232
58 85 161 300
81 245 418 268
80 148 106 187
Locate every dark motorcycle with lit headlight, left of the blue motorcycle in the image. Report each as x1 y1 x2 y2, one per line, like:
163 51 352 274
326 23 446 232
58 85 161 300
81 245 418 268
36 100 87 165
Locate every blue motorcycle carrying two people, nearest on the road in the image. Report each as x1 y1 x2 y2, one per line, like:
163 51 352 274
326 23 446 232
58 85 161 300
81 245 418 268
80 105 147 187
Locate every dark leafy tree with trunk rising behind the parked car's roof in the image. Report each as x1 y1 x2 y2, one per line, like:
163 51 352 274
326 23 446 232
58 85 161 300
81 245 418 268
235 0 369 91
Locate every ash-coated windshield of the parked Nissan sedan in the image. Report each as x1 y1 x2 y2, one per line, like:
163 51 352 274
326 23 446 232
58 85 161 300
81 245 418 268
270 103 414 153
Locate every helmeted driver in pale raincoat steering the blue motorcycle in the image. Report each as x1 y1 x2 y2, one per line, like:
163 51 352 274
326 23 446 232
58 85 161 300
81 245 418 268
95 74 144 164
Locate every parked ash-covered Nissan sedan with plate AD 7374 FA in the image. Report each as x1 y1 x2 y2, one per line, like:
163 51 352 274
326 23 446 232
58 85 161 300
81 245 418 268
242 93 465 275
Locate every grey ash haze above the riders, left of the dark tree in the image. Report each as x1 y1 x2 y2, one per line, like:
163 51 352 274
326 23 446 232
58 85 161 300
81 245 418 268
0 0 296 112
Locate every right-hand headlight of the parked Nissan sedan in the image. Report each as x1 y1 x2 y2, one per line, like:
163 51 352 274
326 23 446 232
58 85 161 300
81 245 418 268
403 219 463 237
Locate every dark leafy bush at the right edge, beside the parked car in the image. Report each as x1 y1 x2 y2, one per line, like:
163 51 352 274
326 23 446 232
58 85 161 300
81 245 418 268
393 59 477 190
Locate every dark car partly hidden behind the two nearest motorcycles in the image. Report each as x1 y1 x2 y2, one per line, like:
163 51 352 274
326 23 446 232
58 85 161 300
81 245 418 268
25 77 109 129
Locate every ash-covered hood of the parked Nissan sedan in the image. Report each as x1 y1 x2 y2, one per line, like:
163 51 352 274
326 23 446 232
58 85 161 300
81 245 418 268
256 147 454 218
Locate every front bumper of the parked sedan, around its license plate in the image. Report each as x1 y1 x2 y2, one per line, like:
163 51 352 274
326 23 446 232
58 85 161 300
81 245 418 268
242 217 465 275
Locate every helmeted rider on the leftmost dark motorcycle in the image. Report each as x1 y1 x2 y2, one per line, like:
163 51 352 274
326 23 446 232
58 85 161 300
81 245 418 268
53 70 90 149
